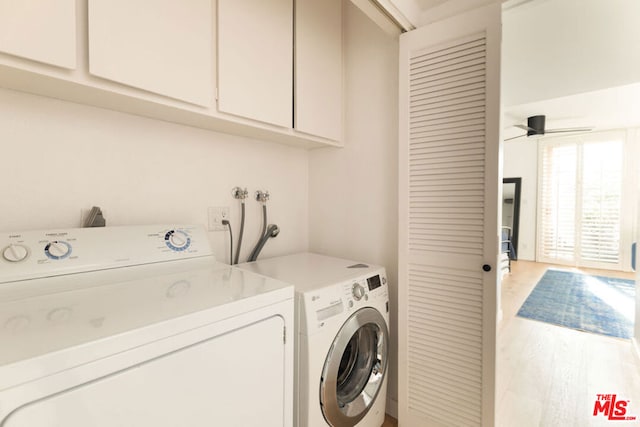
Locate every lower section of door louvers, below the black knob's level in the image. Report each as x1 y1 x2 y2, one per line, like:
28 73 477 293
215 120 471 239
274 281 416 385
408 265 482 425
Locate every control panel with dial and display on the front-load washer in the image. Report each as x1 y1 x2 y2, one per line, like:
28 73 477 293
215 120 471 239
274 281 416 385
300 268 389 334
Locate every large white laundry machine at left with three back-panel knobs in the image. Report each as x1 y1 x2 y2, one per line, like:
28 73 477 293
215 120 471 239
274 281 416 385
0 226 294 427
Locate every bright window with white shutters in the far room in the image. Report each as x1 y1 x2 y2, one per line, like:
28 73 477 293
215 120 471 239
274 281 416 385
538 133 625 269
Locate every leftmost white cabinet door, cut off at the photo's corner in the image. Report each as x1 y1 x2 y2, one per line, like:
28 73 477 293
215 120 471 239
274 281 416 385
0 0 76 69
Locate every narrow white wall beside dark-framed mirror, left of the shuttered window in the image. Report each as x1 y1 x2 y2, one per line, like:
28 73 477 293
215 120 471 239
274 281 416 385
502 138 538 261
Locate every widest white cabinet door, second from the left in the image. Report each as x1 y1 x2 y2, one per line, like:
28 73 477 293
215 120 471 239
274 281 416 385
89 0 214 106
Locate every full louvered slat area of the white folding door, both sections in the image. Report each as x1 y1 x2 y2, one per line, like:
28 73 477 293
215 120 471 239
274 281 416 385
406 35 486 425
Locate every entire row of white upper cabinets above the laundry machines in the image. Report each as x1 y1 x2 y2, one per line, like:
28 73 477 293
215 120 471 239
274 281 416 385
0 0 343 147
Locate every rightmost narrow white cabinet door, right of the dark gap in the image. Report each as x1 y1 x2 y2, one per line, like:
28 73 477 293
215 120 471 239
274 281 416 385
294 0 342 141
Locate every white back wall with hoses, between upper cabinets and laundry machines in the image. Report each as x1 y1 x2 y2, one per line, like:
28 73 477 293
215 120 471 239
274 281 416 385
0 89 309 262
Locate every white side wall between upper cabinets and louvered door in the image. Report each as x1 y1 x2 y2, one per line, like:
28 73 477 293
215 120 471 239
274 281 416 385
309 2 398 414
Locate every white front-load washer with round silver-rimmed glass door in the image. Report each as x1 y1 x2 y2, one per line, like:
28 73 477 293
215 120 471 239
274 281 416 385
239 253 389 427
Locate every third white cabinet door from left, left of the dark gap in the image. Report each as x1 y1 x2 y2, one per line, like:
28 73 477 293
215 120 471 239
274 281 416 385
218 0 293 128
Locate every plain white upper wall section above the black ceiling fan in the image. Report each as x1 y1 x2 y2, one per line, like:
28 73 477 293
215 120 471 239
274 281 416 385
502 0 640 106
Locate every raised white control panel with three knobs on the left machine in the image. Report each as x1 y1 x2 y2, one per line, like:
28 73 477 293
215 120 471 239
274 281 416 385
0 225 212 283
